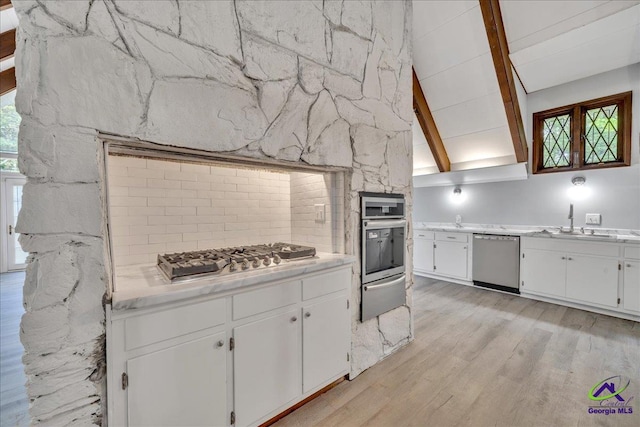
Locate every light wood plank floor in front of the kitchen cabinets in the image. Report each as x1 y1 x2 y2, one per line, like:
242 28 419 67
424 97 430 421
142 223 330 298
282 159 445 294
275 277 640 427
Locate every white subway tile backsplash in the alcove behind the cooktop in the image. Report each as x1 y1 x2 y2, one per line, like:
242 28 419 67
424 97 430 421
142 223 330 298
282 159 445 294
108 156 344 268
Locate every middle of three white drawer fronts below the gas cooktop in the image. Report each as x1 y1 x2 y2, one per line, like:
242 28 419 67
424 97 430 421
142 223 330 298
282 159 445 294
233 280 300 320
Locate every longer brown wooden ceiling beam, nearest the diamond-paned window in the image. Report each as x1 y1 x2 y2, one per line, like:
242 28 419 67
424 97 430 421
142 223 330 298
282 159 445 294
480 0 529 163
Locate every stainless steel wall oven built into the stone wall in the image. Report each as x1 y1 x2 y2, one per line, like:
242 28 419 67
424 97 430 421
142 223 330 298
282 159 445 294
360 193 407 321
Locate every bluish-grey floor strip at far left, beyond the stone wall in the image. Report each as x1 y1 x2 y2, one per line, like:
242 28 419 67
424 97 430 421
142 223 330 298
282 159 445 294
0 272 29 427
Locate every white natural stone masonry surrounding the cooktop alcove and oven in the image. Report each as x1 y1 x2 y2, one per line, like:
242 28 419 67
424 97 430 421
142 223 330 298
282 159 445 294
13 0 413 425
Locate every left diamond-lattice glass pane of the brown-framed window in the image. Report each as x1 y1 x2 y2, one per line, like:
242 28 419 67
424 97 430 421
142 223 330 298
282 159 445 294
542 114 571 168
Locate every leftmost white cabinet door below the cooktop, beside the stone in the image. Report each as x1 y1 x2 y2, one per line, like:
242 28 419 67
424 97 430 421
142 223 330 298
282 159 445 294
127 332 228 426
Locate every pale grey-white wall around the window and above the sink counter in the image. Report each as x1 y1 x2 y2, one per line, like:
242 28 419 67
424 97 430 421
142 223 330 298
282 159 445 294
414 64 640 229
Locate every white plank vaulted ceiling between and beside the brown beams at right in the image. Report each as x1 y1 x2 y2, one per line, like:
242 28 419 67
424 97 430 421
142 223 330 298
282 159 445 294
413 0 640 175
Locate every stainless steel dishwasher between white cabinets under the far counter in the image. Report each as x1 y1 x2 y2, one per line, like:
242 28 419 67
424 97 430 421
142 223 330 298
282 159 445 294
472 234 520 294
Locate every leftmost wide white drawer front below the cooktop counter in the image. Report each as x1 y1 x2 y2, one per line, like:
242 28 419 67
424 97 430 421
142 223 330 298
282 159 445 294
124 298 227 350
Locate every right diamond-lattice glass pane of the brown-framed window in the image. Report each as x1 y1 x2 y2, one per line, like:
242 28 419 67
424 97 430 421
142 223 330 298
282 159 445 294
584 104 618 164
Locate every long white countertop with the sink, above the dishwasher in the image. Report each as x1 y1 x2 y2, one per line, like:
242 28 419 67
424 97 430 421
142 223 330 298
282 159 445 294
413 222 640 244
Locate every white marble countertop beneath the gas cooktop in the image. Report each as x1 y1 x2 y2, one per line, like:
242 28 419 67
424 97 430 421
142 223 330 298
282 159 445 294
111 253 356 311
